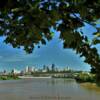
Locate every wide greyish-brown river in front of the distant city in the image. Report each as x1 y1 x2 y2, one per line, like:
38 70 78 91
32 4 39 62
0 78 100 100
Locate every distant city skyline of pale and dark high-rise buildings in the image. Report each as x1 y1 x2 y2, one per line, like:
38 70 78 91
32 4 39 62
0 64 81 74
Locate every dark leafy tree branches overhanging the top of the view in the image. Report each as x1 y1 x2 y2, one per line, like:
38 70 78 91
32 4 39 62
0 0 100 81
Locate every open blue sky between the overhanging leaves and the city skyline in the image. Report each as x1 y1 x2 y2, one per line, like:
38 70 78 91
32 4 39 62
0 24 100 71
